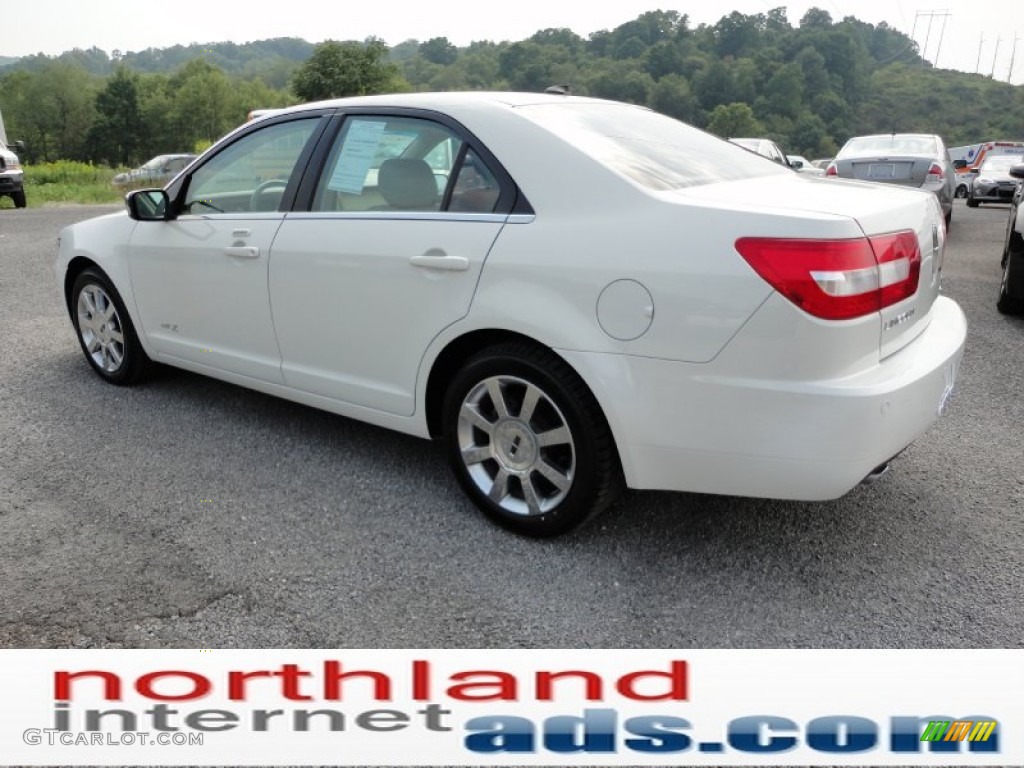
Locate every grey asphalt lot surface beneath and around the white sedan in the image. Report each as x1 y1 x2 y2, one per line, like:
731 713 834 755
0 201 1024 648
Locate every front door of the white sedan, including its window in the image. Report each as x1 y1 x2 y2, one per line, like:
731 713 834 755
129 117 319 383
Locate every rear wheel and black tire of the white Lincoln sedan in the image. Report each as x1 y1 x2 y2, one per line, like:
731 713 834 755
442 342 625 539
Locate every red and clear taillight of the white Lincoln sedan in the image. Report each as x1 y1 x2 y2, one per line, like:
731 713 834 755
736 229 921 319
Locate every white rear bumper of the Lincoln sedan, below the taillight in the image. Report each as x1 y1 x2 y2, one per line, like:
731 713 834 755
562 297 967 501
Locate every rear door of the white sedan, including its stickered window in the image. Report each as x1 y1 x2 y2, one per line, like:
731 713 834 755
269 114 514 416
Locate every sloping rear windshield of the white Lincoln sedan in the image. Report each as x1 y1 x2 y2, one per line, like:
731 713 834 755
518 102 790 190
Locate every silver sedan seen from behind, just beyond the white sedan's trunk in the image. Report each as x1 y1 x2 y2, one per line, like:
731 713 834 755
825 133 955 225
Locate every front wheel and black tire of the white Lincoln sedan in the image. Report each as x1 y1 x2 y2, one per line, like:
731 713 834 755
70 267 153 385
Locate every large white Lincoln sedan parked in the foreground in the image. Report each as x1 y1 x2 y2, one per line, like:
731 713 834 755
56 93 967 537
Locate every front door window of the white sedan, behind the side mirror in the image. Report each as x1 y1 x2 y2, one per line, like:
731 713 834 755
182 117 319 215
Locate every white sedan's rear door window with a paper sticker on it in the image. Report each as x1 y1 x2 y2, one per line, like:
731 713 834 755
312 116 463 212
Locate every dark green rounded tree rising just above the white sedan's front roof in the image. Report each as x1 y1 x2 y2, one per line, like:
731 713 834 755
292 40 408 101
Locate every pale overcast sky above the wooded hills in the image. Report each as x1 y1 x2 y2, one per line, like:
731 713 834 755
6 0 1024 84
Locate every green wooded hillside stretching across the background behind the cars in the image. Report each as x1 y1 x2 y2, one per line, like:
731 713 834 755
0 8 1024 165
